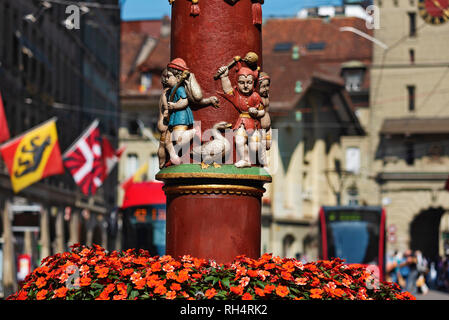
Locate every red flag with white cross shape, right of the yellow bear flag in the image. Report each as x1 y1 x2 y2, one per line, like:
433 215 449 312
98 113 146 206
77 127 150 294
63 120 104 195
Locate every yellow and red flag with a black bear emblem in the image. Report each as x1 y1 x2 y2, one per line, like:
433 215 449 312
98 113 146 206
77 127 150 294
0 118 64 193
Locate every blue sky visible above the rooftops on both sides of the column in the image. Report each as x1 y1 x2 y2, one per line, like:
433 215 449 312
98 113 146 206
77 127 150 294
121 0 342 20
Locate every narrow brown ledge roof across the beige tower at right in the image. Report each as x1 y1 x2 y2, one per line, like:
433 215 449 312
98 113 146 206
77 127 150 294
380 118 449 135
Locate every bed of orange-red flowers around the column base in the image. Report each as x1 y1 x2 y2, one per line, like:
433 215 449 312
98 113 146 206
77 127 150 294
8 245 414 300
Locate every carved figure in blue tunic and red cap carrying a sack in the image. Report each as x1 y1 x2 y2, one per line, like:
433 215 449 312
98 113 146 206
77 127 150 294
159 58 218 168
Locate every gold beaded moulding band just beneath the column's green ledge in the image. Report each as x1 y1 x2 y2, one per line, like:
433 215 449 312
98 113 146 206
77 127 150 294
163 184 265 197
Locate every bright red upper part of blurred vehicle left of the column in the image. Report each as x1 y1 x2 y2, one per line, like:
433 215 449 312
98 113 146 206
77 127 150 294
122 182 166 209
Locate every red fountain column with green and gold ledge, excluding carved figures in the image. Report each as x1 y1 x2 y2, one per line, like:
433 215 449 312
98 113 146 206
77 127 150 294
157 0 271 263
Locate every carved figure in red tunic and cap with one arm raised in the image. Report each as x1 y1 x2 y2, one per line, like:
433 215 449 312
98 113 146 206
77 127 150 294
217 62 265 168
